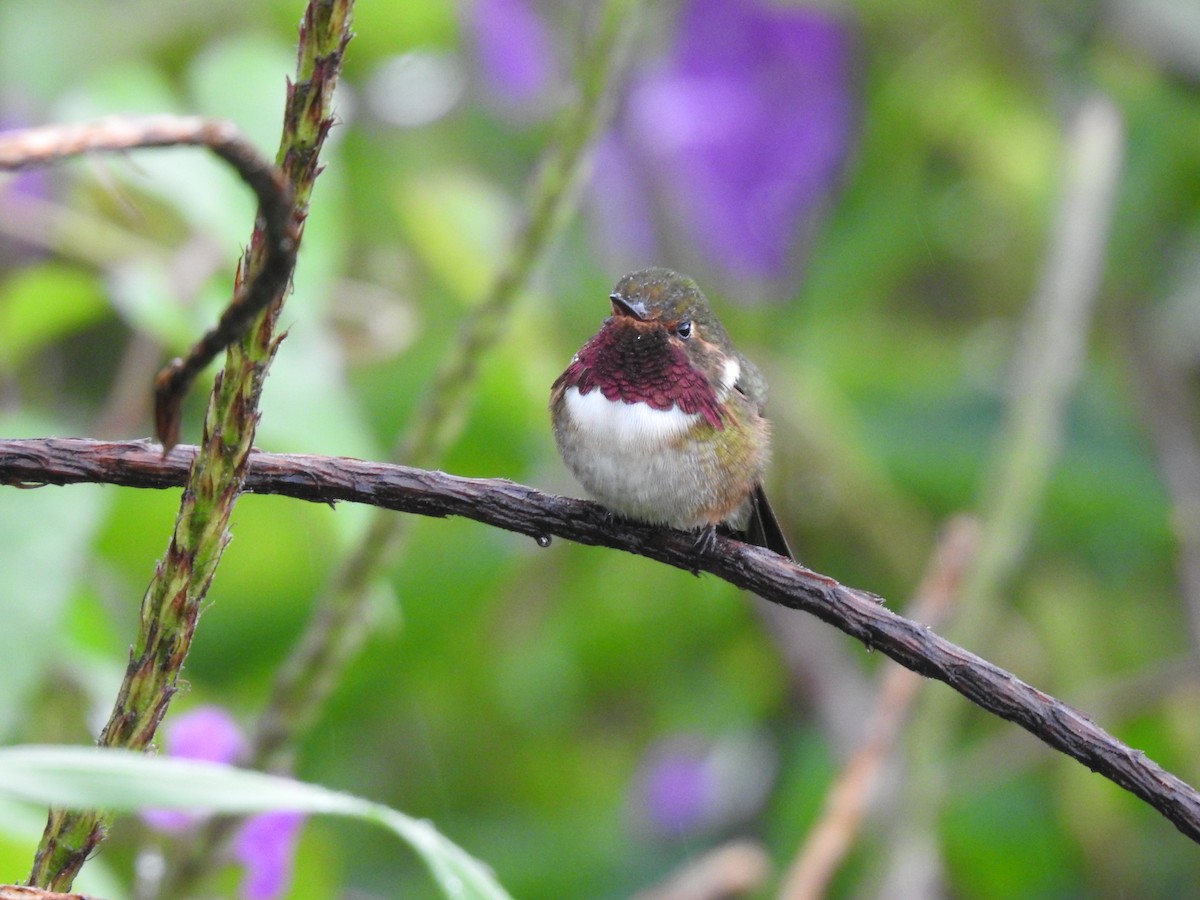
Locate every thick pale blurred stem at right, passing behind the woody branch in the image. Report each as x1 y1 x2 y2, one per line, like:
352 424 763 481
881 96 1123 896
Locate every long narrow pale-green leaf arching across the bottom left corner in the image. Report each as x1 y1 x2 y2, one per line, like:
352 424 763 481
0 745 509 900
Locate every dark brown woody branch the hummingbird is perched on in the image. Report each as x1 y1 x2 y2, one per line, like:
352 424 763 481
0 439 1200 842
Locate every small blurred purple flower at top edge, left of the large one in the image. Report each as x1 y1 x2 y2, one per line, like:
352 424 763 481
469 0 554 104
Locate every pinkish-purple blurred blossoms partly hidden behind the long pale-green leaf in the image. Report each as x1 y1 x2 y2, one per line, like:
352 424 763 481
142 706 304 900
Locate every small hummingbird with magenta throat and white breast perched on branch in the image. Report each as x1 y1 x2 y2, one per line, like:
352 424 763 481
550 269 792 557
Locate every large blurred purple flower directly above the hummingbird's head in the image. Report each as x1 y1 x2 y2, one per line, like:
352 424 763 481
593 0 856 285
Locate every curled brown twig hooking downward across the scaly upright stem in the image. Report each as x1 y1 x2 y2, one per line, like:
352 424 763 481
0 115 299 451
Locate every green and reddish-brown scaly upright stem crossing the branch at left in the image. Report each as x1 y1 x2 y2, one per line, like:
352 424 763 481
30 0 353 890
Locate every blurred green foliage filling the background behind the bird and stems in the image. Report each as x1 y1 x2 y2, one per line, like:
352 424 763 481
0 0 1200 898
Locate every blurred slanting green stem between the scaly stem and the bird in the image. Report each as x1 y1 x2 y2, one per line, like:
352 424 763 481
252 0 642 769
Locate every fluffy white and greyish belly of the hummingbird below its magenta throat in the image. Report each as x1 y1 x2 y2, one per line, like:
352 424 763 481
558 388 706 528
